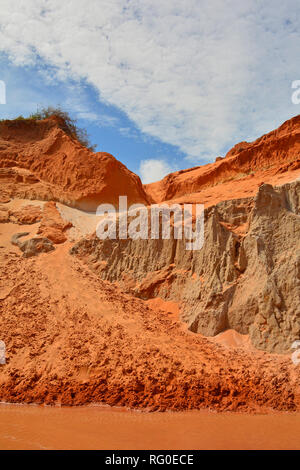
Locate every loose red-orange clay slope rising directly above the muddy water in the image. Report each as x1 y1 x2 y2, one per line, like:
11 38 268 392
0 239 300 411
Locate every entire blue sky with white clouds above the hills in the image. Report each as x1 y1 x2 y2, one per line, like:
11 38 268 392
0 0 300 182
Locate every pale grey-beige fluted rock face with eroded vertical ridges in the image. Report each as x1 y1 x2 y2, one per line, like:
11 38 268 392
71 181 300 352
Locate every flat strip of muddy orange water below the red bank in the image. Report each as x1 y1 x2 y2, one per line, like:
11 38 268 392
0 404 300 450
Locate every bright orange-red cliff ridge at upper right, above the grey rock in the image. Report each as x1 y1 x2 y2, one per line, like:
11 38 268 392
145 116 300 205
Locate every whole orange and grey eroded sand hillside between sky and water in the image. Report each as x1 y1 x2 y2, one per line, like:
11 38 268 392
0 117 300 411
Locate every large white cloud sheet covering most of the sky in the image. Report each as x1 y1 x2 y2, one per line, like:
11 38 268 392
0 0 300 161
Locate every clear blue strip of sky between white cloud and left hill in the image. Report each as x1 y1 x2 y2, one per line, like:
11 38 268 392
0 54 183 180
